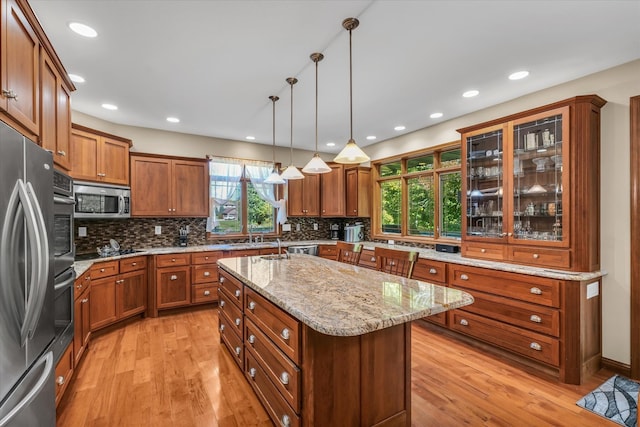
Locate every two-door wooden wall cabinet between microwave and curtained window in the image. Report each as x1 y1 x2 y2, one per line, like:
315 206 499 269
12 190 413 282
131 154 209 217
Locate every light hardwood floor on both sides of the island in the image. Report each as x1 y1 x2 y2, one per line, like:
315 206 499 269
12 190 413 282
57 306 613 427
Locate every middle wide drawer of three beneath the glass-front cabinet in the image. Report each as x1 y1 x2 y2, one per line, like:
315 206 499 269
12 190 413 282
452 290 560 337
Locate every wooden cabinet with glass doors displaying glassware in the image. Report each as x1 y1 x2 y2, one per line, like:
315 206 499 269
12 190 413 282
459 95 606 271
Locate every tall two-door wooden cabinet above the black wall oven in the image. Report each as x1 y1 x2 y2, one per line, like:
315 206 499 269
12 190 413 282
39 48 71 170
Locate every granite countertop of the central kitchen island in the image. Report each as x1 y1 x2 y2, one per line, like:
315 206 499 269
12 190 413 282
218 254 473 336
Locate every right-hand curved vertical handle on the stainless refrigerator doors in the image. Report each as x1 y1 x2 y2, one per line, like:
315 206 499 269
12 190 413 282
22 182 49 338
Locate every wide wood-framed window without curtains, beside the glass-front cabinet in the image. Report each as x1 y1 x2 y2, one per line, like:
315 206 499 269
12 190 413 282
373 141 462 241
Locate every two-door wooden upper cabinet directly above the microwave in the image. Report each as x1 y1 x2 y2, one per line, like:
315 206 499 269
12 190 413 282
69 124 131 186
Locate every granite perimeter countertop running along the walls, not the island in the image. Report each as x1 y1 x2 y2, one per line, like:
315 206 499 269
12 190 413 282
74 240 607 281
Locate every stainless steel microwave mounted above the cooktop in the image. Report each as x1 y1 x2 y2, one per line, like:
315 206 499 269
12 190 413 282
73 181 131 219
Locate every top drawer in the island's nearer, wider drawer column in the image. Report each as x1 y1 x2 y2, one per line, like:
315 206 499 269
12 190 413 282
244 288 300 364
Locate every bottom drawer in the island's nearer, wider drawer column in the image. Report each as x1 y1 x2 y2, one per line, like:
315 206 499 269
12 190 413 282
244 352 301 427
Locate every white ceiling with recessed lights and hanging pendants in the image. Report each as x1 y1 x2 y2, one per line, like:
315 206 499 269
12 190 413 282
30 0 640 152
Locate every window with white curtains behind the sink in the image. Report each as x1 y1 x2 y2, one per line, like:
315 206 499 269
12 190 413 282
207 157 279 237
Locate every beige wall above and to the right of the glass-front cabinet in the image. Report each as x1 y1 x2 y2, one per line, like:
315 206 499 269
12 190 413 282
365 60 640 364
